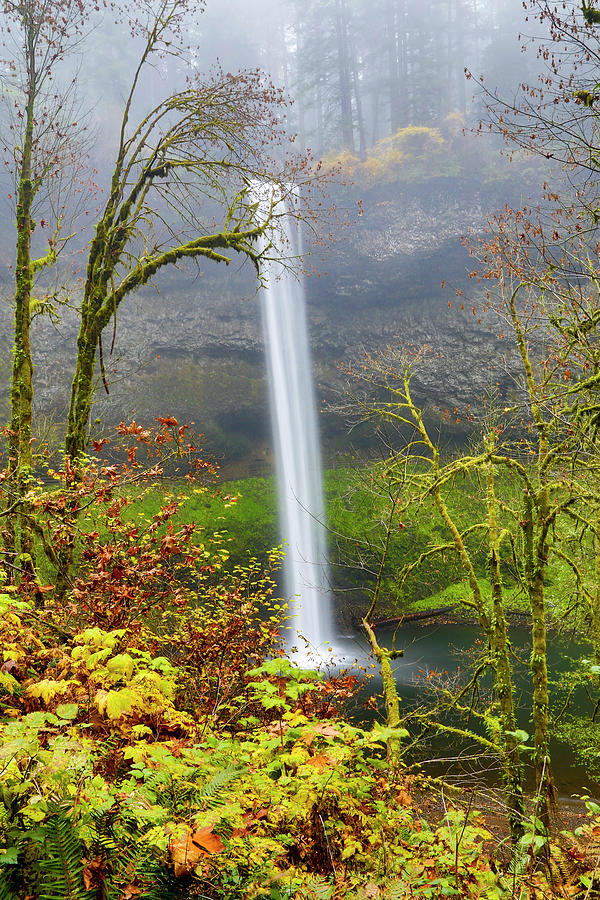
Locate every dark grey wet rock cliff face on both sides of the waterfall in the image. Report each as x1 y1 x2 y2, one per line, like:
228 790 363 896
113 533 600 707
0 182 510 468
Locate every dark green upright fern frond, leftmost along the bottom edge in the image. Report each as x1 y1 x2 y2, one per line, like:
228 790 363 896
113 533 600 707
37 811 94 900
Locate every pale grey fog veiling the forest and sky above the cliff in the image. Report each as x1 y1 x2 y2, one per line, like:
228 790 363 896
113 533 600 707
0 0 535 265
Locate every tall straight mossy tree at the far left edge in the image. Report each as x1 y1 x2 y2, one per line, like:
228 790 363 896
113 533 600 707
0 0 85 573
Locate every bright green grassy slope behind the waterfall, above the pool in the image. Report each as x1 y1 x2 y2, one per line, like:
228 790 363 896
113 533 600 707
124 468 588 615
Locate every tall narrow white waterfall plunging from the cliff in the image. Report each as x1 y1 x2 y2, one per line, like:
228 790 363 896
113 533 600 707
256 186 333 656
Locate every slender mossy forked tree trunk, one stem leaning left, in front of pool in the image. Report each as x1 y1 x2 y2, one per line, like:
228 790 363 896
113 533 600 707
354 362 525 846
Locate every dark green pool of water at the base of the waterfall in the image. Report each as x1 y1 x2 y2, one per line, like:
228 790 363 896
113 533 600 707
297 624 599 796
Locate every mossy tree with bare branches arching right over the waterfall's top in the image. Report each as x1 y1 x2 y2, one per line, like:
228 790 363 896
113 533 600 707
65 0 318 459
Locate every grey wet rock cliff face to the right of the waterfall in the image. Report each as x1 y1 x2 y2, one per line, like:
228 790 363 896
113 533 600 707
307 184 515 428
